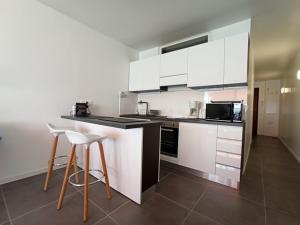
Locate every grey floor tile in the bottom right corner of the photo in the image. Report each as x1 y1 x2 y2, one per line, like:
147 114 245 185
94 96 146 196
267 209 300 225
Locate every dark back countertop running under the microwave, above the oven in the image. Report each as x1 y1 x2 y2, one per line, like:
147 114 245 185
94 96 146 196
120 114 245 127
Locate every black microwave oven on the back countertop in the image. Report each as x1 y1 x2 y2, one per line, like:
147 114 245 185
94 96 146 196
206 101 243 122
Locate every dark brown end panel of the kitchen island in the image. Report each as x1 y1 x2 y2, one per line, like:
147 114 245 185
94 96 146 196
142 126 160 192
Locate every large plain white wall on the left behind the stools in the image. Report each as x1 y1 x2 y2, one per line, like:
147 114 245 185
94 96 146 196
0 0 137 183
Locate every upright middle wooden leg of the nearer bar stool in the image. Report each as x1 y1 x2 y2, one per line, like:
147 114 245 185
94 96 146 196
83 146 90 222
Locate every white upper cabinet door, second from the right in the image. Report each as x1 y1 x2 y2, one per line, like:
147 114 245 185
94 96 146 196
188 39 224 87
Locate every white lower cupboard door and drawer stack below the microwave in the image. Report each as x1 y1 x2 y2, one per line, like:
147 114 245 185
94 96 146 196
177 123 243 185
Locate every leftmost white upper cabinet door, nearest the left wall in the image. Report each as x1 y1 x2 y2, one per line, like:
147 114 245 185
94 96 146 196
129 56 160 91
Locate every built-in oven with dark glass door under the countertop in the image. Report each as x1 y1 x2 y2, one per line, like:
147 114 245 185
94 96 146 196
160 121 179 158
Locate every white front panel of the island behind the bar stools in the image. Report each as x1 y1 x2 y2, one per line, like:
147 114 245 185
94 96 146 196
76 122 143 204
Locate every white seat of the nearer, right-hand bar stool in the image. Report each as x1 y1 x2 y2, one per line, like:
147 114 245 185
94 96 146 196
65 130 106 145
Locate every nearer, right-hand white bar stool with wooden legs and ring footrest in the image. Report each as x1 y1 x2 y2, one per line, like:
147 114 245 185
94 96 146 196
57 131 111 222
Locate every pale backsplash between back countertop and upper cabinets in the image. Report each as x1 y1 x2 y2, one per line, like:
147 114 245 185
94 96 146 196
138 88 247 117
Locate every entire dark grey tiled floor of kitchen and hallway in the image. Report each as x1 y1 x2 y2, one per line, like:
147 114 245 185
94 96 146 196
0 137 300 225
